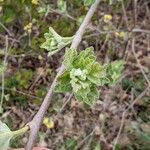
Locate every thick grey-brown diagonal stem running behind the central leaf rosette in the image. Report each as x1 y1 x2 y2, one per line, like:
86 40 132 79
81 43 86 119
26 0 100 150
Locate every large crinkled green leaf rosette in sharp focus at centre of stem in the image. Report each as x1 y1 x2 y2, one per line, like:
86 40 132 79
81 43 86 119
55 47 102 105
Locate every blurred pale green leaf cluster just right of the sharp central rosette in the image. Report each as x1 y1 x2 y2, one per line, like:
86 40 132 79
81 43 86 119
107 60 125 86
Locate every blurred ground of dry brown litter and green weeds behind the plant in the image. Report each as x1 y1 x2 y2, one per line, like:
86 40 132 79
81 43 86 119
0 0 150 150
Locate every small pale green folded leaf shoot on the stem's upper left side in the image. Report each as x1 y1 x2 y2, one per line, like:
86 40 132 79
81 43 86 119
41 27 73 56
